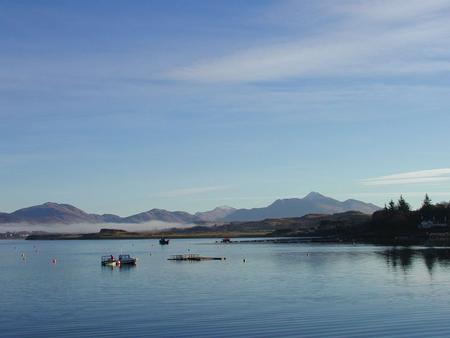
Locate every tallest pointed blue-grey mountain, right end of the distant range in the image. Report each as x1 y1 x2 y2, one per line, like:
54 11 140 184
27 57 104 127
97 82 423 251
222 192 380 222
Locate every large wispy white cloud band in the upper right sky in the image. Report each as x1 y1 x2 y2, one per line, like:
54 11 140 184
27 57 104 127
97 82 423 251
167 0 450 82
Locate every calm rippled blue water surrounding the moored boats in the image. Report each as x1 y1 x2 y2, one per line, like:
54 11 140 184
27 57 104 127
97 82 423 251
0 239 450 337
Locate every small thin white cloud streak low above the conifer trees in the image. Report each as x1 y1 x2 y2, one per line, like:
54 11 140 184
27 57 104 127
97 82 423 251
362 168 450 185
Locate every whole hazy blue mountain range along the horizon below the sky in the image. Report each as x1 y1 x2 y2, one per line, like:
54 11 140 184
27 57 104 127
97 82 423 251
0 192 380 225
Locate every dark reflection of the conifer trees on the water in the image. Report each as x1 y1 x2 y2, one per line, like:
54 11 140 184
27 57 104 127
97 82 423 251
381 248 450 275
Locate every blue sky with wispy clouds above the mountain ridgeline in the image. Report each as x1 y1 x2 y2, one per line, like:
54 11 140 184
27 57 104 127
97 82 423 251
0 0 450 216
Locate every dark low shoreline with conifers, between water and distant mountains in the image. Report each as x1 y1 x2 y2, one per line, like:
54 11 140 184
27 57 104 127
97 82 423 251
26 195 450 246
